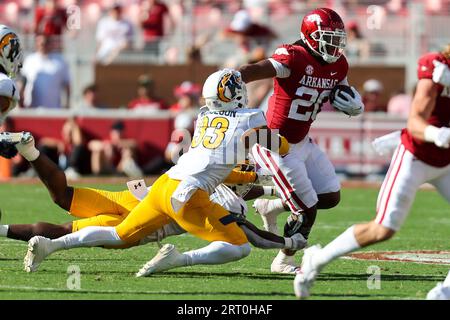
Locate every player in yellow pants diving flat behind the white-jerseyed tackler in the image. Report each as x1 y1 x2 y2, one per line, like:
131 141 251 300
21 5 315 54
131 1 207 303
0 138 302 255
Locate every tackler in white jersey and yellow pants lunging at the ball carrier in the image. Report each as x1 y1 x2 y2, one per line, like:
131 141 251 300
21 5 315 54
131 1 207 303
24 69 306 276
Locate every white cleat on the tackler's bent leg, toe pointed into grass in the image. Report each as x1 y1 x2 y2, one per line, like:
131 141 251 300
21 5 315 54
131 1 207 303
136 244 186 277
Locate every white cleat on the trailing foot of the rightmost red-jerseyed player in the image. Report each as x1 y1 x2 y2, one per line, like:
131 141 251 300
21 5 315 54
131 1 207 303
294 245 321 299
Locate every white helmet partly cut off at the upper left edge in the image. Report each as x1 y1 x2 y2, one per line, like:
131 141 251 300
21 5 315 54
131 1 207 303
0 24 23 78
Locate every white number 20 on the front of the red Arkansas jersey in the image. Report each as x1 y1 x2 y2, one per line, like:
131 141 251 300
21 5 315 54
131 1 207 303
288 87 331 121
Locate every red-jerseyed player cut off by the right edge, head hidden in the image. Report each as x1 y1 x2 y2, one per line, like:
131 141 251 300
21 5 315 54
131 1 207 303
294 45 450 298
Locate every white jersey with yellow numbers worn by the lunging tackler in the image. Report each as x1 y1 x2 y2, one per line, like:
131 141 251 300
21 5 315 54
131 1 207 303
167 107 266 194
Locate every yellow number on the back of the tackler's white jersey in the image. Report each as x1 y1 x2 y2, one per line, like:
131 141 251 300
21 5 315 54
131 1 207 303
191 116 229 149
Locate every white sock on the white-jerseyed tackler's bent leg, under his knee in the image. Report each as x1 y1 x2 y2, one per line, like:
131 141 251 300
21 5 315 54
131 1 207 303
183 241 250 266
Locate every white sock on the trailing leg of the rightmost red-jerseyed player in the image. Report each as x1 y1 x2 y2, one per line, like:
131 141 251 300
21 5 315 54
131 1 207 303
314 225 361 267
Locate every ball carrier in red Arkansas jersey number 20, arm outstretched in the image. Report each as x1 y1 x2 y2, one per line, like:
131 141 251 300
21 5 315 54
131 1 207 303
240 8 364 273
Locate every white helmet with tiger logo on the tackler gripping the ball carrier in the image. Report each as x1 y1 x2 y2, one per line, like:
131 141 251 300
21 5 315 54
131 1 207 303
203 69 248 111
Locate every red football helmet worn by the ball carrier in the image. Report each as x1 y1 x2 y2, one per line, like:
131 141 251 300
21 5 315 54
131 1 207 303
300 8 347 63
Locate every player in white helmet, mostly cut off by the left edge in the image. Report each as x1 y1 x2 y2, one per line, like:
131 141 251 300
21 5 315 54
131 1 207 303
0 25 23 123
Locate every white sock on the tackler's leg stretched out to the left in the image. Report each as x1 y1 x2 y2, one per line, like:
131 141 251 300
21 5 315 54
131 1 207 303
52 226 125 251
